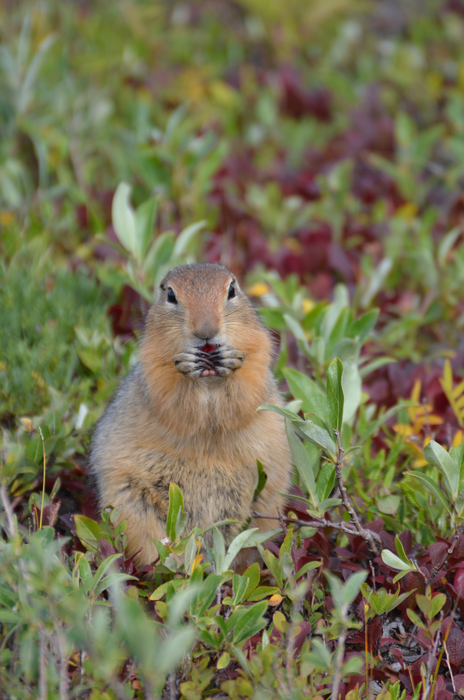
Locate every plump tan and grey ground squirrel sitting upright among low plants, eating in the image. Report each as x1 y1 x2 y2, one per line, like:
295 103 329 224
91 263 291 566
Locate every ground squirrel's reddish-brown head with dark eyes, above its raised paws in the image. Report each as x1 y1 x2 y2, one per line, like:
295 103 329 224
145 263 270 374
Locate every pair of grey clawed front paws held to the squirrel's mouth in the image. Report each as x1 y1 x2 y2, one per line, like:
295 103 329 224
171 345 245 379
